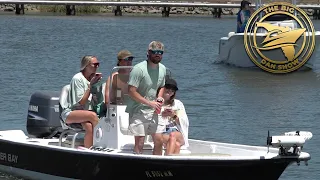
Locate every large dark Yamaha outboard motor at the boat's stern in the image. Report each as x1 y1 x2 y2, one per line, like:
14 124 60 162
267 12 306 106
27 92 62 138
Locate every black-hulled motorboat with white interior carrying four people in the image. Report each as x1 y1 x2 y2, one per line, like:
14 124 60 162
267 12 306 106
0 67 312 180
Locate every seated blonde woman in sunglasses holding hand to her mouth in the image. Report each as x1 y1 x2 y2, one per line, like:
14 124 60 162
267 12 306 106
60 56 103 148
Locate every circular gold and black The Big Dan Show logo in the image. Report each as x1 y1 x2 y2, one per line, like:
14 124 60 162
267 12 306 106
244 2 315 73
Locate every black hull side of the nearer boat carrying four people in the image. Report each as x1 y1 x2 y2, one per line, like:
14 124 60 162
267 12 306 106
0 139 294 180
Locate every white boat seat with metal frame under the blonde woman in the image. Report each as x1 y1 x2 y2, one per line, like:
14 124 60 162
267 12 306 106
59 84 85 148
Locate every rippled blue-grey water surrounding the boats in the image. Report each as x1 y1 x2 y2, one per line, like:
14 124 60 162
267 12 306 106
0 11 320 180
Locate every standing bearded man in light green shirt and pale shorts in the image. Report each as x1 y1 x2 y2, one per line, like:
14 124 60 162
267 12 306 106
126 41 166 155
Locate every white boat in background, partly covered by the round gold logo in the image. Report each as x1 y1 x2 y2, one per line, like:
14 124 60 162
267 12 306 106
216 1 320 70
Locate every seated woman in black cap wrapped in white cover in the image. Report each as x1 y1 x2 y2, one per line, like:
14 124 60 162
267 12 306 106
159 78 189 155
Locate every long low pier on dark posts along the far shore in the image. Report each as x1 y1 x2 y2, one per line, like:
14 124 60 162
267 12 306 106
0 0 320 17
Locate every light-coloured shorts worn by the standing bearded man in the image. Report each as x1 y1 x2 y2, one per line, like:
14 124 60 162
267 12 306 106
129 113 166 136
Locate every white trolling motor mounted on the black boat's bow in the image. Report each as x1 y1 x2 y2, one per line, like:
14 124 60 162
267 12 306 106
267 131 312 156
